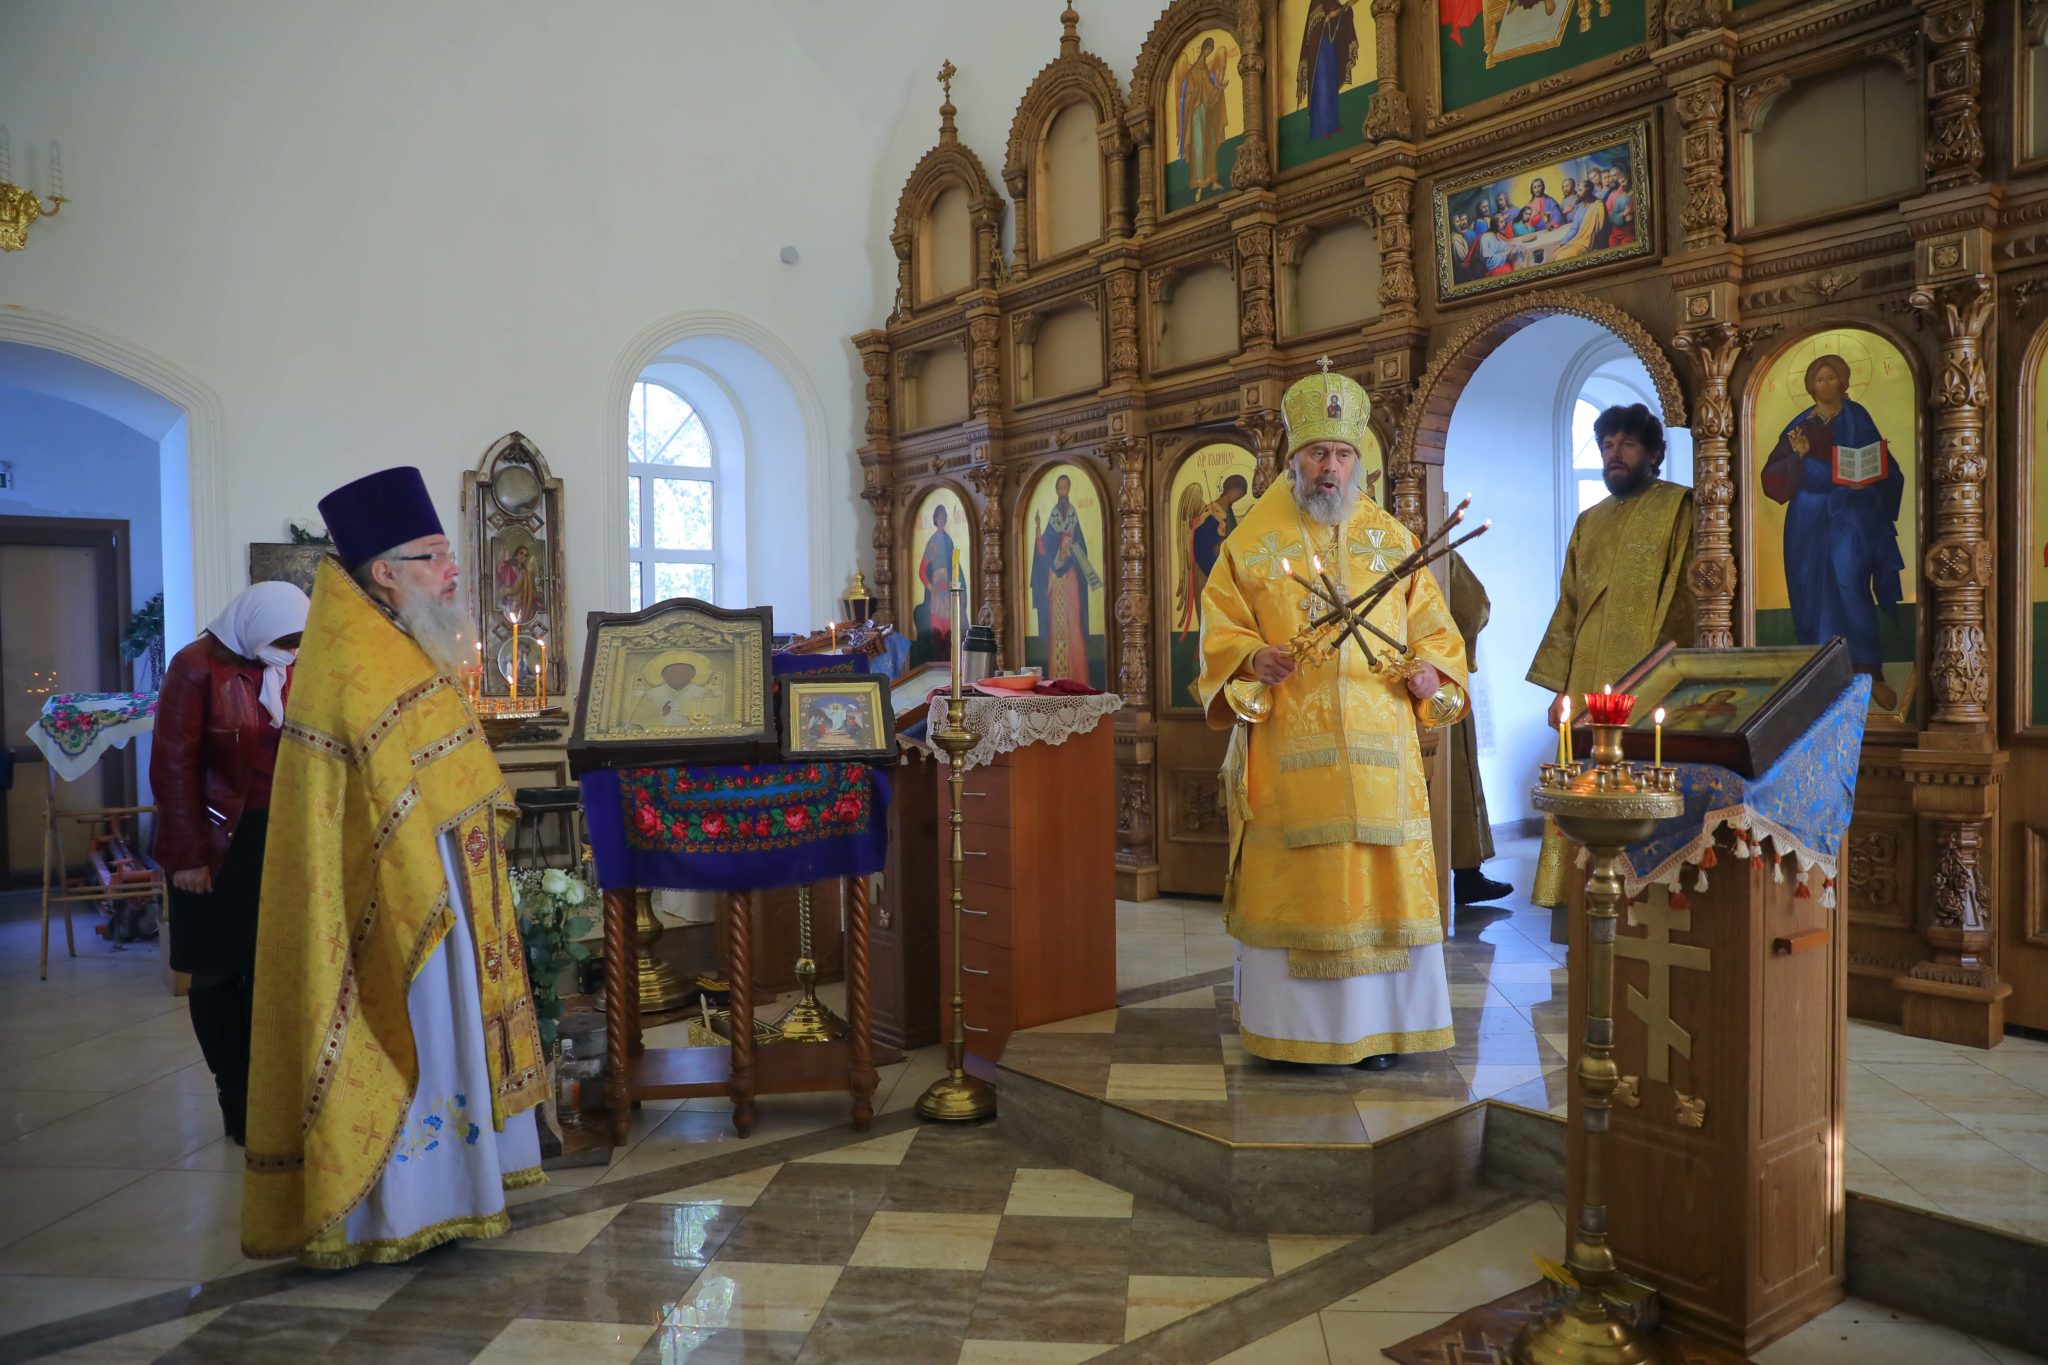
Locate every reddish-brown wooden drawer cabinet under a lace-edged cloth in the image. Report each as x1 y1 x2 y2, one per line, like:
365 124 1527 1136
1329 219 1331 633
936 724 1116 1060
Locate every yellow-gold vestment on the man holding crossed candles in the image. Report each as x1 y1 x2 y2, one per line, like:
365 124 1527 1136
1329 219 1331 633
1198 479 1466 994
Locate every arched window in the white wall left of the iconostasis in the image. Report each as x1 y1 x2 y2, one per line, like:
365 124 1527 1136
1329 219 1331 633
627 379 719 612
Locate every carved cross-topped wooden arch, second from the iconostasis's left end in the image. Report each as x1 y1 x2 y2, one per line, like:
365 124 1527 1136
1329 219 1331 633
1004 4 1130 278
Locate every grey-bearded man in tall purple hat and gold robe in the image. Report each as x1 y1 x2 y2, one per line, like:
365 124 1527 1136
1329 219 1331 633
242 469 547 1269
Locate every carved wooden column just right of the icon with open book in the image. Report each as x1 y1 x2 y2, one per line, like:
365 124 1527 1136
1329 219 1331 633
1911 274 1997 731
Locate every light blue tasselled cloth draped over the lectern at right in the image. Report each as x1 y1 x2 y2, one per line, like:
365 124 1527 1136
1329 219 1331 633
1622 675 1870 905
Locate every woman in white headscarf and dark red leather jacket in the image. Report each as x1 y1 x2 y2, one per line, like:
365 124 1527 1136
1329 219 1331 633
150 583 311 1144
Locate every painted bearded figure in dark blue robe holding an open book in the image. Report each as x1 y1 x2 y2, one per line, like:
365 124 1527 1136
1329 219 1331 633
1763 356 1907 710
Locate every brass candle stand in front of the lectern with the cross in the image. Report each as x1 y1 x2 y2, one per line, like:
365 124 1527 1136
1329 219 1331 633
1509 708 1686 1365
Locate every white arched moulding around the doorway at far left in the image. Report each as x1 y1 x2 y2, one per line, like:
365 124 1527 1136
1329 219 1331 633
0 305 236 626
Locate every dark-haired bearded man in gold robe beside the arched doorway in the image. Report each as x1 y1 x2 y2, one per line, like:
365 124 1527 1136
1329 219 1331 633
1528 403 1696 909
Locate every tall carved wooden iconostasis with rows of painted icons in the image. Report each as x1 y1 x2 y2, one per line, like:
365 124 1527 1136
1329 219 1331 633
854 0 2048 1046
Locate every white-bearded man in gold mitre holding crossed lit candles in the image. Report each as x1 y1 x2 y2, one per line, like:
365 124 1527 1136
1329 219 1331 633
1198 372 1466 1070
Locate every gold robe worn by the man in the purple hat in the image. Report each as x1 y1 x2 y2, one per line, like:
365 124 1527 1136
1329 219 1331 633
242 559 547 1269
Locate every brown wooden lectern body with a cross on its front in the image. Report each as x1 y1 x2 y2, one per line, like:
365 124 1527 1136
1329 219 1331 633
1567 829 1847 1355
